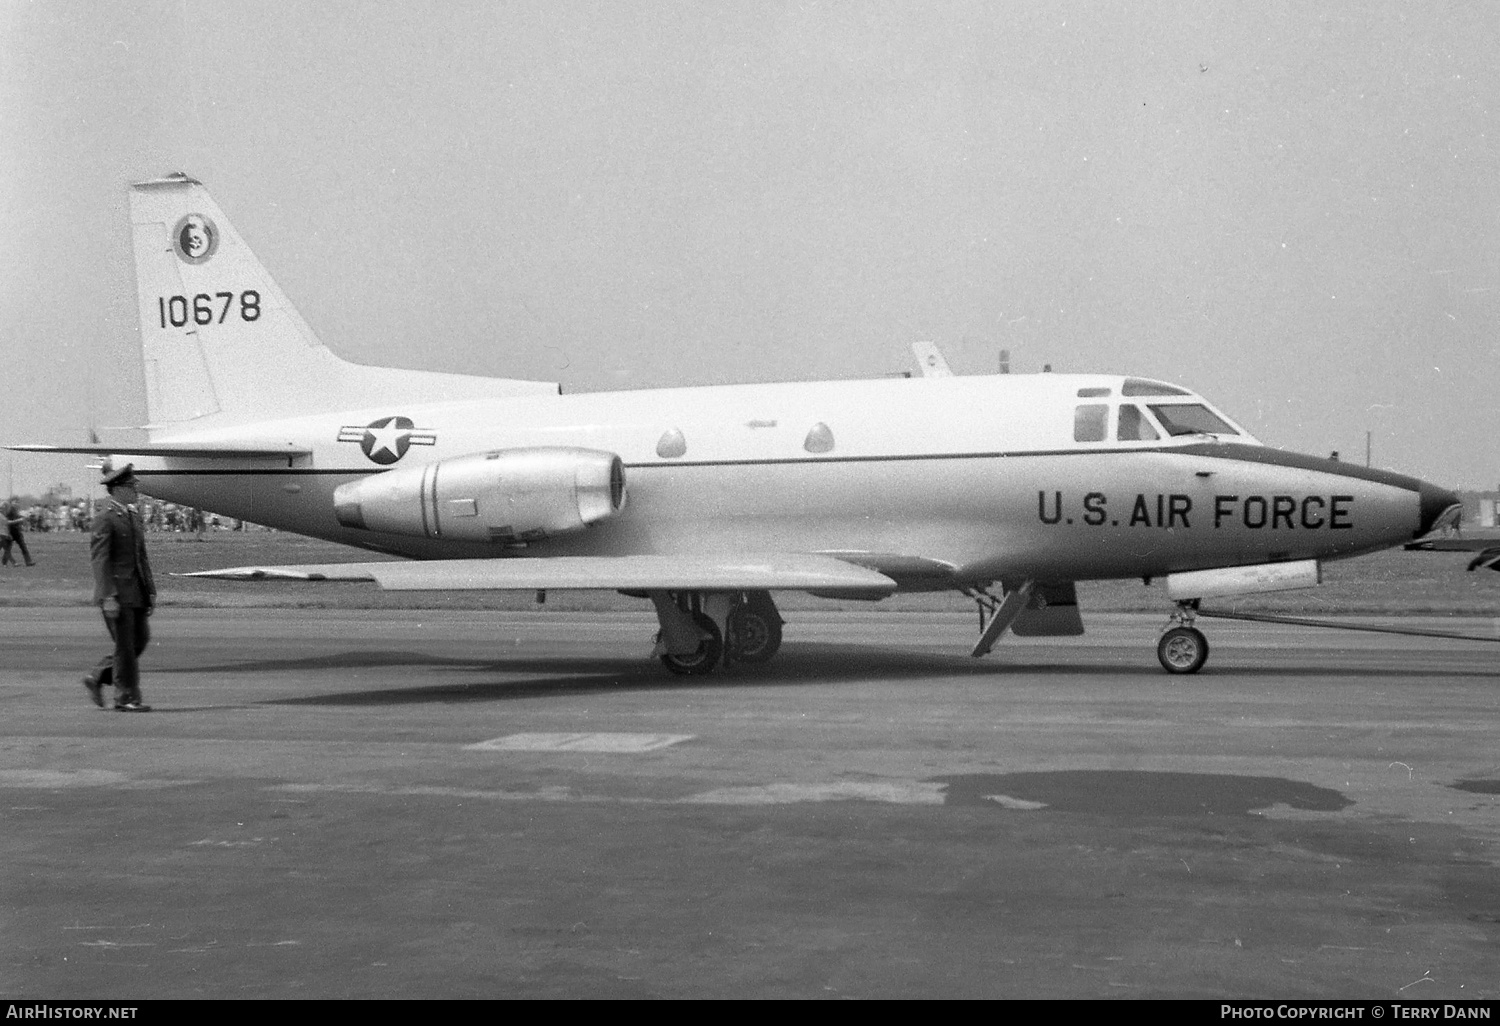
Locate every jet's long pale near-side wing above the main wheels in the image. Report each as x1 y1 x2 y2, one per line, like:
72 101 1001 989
176 554 896 593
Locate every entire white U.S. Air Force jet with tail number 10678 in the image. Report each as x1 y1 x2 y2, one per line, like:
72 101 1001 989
15 174 1458 674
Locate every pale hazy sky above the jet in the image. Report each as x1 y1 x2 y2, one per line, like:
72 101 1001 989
0 0 1500 491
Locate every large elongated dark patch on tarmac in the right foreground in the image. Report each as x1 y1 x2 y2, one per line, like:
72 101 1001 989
932 770 1355 818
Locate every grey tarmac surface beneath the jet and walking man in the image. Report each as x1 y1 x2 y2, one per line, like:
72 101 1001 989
0 608 1500 1001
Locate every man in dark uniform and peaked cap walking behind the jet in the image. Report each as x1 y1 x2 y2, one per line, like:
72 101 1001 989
84 464 156 713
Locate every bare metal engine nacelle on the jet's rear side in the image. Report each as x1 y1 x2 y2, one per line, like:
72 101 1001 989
333 447 626 543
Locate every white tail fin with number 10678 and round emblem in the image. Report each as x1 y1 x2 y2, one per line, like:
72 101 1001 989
131 174 558 428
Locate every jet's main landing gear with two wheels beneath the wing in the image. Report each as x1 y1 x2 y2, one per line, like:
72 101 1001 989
650 591 783 677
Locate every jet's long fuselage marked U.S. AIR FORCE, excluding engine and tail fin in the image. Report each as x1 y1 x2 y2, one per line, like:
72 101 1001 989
126 375 1421 581
